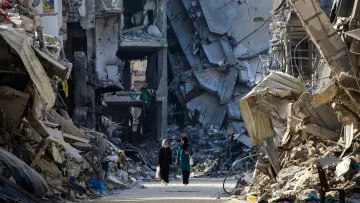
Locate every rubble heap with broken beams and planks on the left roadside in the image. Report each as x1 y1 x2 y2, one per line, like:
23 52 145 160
0 0 153 202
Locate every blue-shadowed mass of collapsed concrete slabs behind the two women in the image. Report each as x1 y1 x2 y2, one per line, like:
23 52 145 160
167 0 272 176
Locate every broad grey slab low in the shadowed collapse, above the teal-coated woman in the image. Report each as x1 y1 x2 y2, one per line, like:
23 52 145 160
186 93 226 128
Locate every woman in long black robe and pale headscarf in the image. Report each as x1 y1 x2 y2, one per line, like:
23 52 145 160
158 139 172 186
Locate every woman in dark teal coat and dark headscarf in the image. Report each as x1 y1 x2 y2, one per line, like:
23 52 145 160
176 137 193 185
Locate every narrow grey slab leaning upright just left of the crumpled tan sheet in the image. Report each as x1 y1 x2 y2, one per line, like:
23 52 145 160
220 67 238 104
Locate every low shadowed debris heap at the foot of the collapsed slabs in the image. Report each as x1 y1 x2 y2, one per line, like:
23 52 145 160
163 124 256 178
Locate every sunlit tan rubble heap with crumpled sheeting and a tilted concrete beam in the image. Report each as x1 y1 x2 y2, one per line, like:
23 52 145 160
232 0 360 202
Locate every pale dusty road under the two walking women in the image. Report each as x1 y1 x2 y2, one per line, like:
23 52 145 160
85 179 248 203
